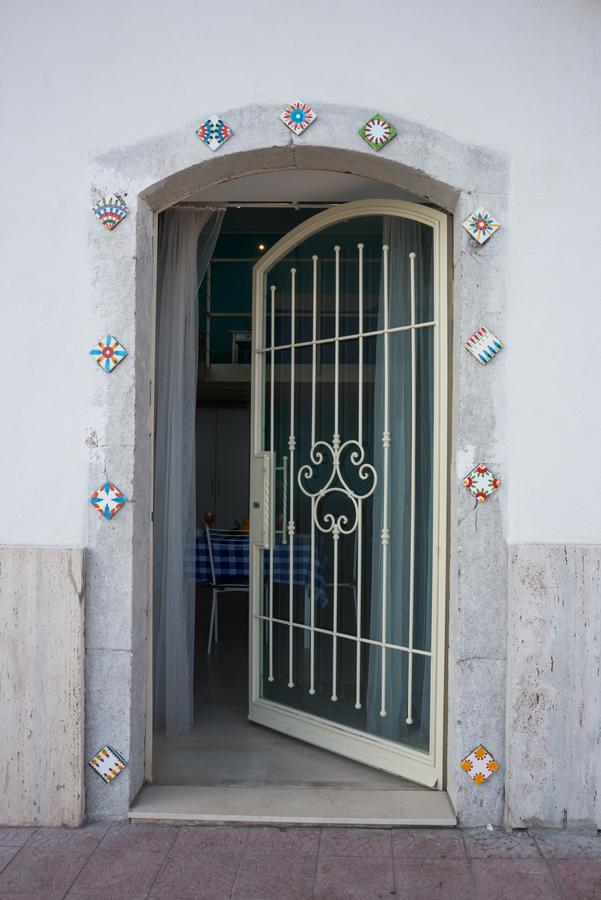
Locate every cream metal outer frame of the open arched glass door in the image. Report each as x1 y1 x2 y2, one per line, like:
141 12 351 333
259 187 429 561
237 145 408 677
249 200 448 789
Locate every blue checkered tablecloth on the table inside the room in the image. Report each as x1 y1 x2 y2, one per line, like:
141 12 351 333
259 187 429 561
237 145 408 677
187 535 328 607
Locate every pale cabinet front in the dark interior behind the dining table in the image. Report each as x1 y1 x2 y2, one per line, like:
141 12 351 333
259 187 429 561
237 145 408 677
196 408 250 528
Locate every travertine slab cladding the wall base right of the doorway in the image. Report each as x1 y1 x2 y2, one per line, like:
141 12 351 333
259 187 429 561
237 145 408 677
505 544 601 828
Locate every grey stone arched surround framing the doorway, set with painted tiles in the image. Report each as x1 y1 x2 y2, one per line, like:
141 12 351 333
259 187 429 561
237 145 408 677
86 105 508 824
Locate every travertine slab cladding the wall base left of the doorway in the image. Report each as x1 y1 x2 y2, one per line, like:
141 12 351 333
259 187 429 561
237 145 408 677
0 547 85 827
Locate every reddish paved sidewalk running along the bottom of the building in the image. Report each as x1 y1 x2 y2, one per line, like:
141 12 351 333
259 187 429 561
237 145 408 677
0 824 601 900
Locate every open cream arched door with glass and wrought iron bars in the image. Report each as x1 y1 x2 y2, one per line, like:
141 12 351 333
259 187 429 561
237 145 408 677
249 201 446 787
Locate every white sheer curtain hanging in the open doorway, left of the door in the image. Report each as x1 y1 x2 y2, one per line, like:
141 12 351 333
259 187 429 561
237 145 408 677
153 209 224 737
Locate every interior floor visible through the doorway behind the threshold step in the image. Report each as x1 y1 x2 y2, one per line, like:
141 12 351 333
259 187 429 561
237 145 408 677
153 586 423 791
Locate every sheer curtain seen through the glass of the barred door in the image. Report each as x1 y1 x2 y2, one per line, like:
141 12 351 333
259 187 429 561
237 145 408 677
367 217 433 749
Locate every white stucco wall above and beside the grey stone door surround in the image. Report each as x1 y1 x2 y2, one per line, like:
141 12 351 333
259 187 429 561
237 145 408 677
0 0 601 545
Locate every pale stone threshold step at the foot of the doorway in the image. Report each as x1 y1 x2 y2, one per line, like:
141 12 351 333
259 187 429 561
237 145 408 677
129 784 457 827
